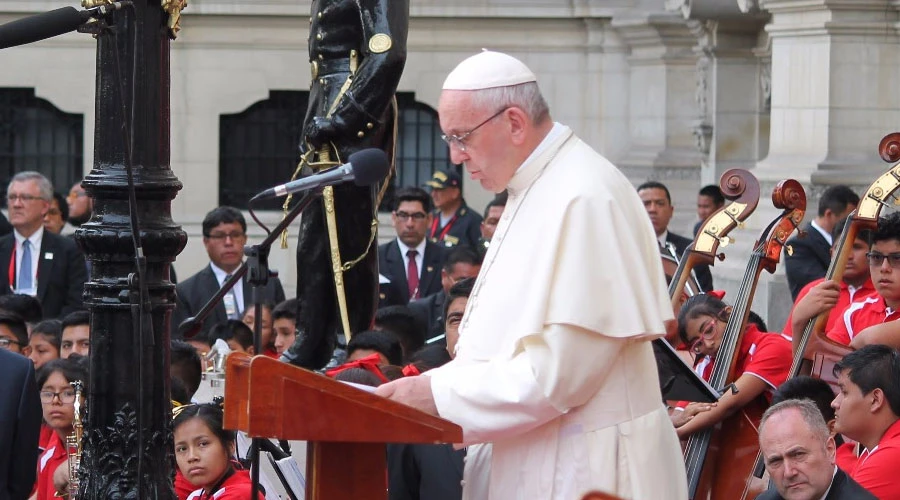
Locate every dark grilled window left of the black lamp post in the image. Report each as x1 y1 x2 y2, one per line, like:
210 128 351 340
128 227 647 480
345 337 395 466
0 88 84 199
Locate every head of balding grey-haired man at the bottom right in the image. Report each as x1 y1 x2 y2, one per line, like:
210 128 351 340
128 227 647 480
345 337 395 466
759 408 835 500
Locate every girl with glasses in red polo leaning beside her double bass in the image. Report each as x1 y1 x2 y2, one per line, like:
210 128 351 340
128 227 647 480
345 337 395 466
676 294 791 438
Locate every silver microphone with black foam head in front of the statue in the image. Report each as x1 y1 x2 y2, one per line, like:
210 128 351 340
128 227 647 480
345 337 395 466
250 148 390 202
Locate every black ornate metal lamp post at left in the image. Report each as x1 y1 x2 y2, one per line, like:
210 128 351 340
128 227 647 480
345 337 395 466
76 0 187 500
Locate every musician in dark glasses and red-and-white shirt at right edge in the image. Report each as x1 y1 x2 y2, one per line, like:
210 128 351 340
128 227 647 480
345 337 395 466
828 212 900 348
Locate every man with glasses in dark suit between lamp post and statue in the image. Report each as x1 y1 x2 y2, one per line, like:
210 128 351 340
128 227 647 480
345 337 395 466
172 206 285 340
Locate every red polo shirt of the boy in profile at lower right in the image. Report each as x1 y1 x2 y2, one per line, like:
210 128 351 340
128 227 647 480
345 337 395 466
848 420 900 498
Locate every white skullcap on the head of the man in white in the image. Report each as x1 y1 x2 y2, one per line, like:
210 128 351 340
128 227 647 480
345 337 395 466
443 50 537 90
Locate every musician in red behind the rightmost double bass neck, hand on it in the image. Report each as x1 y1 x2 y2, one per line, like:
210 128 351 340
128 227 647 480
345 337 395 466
782 219 876 347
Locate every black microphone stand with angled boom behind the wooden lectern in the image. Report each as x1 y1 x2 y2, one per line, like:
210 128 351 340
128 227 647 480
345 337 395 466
178 187 324 500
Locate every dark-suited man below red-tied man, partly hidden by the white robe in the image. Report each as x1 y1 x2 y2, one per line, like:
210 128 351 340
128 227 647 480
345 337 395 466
409 245 481 345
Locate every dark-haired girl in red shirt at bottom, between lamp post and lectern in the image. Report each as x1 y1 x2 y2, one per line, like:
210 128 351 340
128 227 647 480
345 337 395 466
172 404 265 500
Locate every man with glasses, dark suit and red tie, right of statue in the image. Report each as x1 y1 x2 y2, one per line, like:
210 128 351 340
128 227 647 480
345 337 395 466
378 188 444 306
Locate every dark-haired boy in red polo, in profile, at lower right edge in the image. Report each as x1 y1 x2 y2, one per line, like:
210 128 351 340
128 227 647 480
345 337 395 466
831 345 900 498
